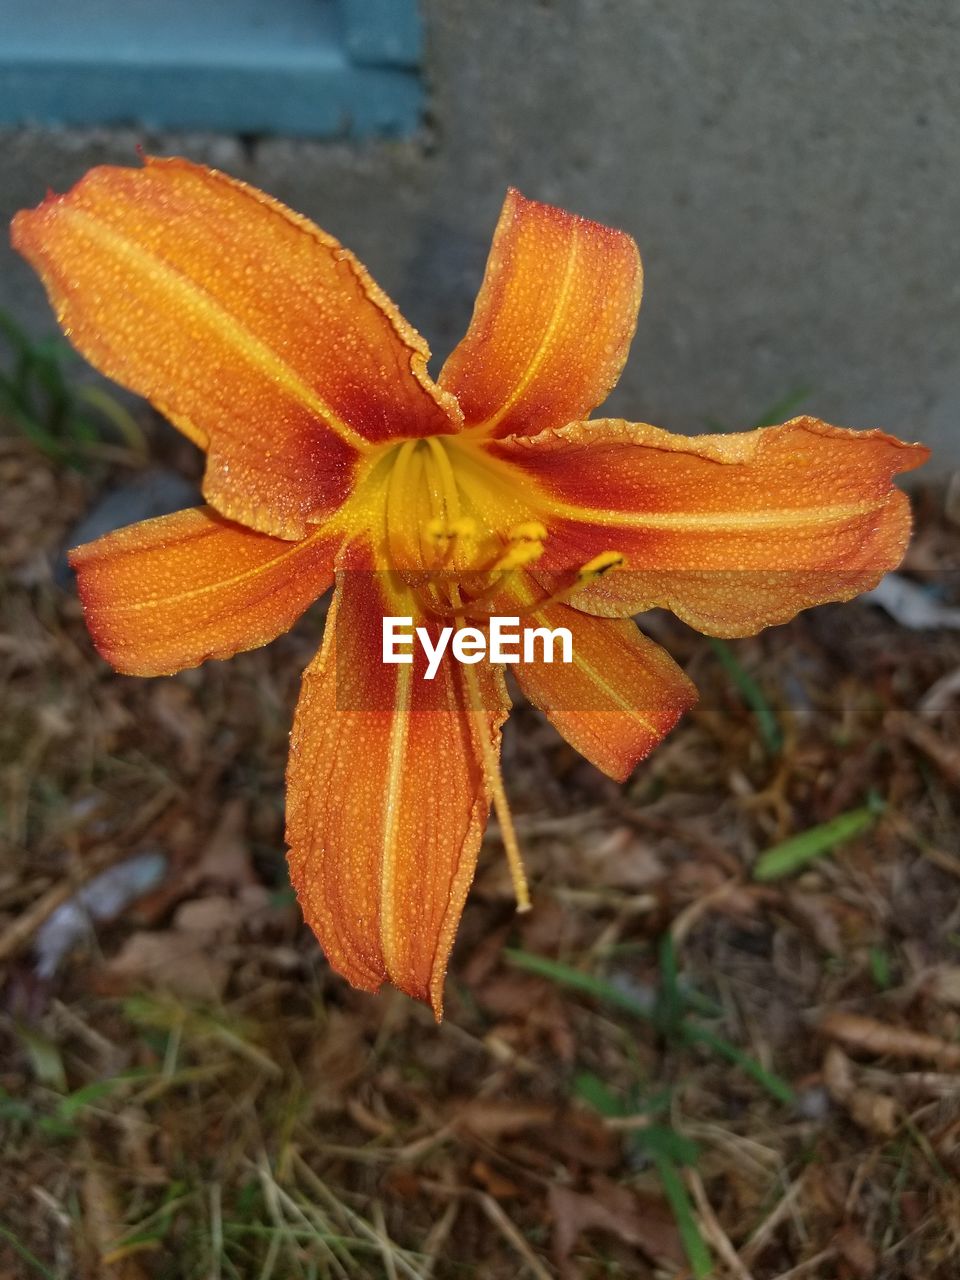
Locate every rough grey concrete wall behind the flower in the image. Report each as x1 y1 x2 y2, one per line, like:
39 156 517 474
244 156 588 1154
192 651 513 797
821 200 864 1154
0 0 960 470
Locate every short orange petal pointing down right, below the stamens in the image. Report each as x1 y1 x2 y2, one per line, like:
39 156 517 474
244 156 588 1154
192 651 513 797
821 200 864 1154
513 604 696 782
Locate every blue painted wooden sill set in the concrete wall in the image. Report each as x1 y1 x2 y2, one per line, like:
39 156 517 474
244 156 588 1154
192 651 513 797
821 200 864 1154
0 0 422 137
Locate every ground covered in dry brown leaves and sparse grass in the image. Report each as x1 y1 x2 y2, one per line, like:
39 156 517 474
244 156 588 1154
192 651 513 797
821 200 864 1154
0 412 960 1280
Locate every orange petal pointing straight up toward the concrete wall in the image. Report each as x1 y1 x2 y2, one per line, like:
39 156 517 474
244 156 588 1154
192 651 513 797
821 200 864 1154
439 189 643 436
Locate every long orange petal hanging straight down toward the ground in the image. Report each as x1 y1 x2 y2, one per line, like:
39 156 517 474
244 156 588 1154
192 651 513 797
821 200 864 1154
287 555 509 1019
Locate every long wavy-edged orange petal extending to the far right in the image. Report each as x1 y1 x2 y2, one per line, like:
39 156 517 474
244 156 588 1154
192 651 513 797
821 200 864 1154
489 417 928 636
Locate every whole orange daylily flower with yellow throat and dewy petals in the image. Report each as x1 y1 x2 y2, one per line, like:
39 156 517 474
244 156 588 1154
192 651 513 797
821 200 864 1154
13 159 927 1016
